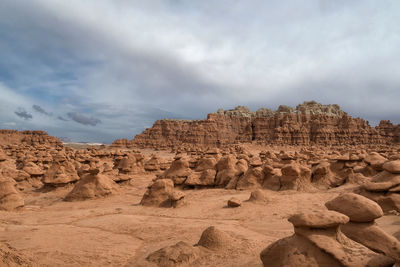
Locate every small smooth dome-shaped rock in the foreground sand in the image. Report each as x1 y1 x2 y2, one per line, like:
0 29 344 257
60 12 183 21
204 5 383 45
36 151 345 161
197 226 234 250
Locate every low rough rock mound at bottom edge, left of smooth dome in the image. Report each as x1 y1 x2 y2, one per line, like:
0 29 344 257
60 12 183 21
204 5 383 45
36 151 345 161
146 241 200 267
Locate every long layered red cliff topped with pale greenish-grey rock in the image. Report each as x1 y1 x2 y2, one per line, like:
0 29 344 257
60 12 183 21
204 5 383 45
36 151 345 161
114 101 400 150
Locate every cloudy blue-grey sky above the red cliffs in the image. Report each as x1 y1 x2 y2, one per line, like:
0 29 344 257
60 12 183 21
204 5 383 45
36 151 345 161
0 0 400 143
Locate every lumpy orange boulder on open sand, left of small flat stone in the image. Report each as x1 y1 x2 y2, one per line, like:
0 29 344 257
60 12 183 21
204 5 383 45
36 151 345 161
140 179 185 208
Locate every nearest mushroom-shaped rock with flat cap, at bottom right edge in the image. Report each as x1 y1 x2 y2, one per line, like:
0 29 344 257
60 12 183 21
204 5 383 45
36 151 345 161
260 210 394 267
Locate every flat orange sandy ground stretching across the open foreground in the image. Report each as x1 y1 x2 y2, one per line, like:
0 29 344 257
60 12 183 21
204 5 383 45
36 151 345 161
0 175 400 266
